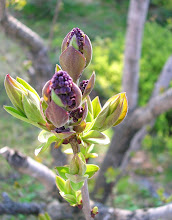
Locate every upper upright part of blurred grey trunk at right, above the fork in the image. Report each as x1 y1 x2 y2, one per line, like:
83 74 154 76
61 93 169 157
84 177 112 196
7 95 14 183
122 0 149 110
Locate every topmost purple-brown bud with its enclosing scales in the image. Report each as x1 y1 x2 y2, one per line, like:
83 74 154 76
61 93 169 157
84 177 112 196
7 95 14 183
59 28 92 82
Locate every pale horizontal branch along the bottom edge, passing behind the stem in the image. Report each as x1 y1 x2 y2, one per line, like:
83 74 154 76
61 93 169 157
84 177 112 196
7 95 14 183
47 202 172 220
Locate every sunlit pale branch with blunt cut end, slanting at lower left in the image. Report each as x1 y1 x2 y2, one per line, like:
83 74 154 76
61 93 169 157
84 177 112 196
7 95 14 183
0 147 58 194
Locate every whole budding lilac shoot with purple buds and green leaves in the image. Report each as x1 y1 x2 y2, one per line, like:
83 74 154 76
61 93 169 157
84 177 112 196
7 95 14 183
4 28 128 219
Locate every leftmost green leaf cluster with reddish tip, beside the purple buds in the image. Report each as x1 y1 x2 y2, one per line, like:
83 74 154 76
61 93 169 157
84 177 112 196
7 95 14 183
4 75 46 130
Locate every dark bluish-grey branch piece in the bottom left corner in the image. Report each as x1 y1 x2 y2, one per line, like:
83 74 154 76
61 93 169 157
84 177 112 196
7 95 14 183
0 192 45 215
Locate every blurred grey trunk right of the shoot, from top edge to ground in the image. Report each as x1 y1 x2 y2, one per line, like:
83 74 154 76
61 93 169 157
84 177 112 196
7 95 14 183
92 0 149 202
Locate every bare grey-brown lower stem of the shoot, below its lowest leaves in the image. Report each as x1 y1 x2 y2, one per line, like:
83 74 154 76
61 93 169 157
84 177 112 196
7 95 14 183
81 180 93 220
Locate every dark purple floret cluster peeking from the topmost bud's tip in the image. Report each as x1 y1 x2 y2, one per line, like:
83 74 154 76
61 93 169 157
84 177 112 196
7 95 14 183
67 28 84 53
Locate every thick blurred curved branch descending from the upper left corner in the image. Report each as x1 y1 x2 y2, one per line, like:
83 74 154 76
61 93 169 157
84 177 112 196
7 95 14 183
0 0 52 91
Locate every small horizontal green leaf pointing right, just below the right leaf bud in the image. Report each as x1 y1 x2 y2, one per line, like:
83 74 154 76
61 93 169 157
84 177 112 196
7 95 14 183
82 130 110 144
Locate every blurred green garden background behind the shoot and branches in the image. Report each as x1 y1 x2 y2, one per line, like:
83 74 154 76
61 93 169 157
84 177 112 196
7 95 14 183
0 0 172 220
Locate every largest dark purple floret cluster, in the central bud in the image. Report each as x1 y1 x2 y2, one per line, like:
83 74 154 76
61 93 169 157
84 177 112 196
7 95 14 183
51 70 76 109
